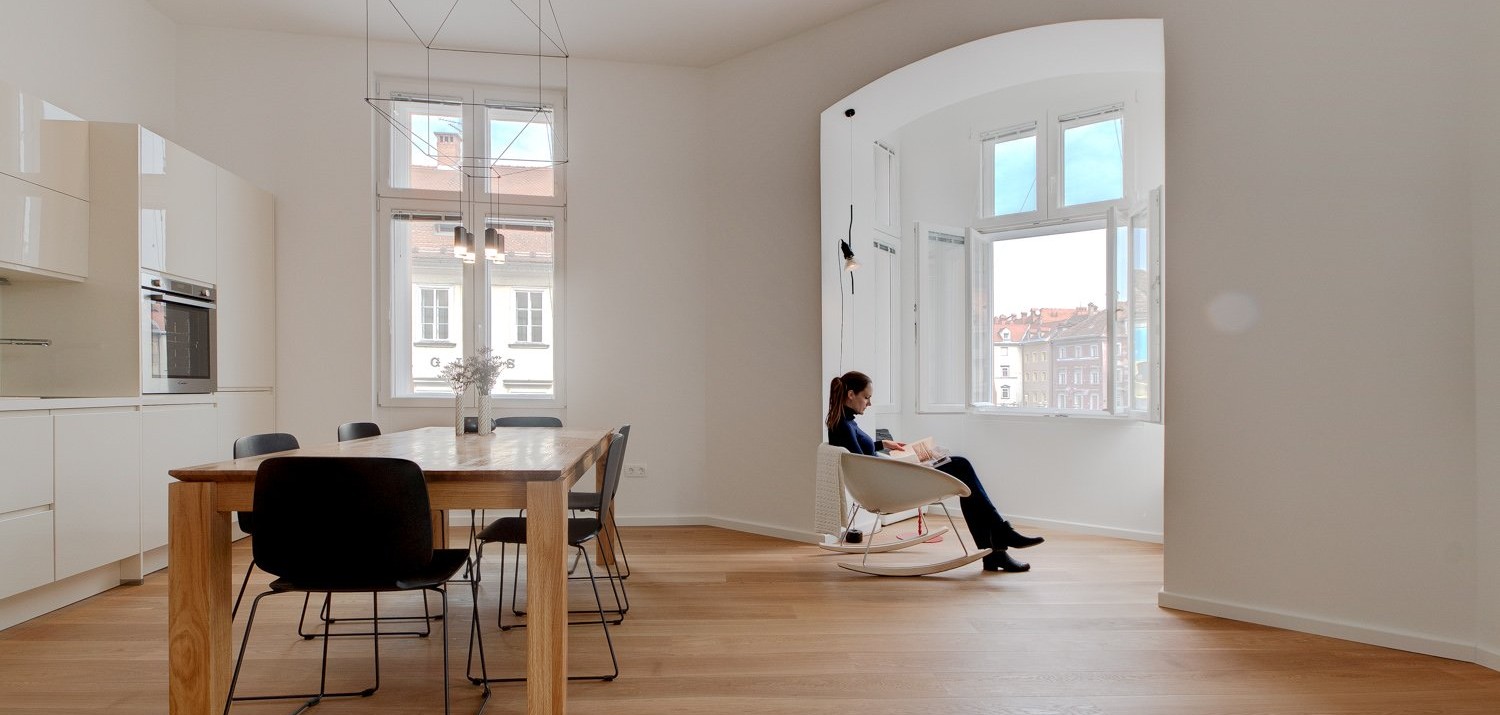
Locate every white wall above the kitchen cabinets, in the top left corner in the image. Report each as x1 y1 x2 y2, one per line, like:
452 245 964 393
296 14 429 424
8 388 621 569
0 0 177 136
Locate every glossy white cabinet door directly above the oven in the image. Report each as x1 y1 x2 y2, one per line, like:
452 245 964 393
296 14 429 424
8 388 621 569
140 127 218 283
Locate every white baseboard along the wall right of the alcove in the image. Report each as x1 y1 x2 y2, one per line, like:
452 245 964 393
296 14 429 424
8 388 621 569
1157 589 1476 659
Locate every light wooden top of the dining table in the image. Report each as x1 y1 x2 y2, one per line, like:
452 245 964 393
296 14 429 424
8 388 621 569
168 427 614 483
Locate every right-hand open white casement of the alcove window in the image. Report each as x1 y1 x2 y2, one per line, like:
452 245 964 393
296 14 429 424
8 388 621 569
1109 186 1163 423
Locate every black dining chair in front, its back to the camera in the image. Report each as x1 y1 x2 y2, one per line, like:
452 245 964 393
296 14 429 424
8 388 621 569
224 457 479 715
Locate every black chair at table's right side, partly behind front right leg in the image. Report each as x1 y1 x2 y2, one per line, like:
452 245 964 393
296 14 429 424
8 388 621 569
468 432 626 685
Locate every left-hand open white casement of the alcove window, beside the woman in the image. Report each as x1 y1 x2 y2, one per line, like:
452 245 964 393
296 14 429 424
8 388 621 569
915 223 971 412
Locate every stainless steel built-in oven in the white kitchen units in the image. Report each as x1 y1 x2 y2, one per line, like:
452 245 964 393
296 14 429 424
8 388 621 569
141 271 219 394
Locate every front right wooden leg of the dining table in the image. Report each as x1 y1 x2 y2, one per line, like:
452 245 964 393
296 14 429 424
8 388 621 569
527 480 567 715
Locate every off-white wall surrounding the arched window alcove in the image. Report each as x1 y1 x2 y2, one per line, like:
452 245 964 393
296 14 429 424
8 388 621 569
708 0 1500 657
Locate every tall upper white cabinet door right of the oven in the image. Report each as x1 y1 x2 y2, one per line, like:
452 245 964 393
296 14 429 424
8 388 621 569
218 169 276 388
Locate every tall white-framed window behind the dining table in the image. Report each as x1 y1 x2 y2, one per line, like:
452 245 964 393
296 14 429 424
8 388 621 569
375 79 566 405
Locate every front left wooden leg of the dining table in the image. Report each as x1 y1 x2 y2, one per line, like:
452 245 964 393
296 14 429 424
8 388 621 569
167 481 233 715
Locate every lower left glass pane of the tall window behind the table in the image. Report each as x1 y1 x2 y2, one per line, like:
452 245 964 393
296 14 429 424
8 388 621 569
390 214 464 396
